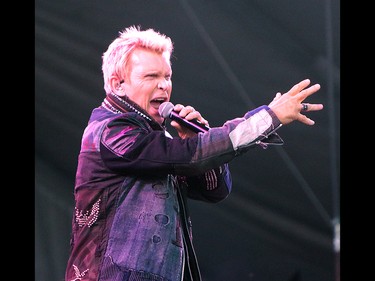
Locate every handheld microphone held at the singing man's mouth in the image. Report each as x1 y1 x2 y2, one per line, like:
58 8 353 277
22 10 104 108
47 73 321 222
159 102 210 133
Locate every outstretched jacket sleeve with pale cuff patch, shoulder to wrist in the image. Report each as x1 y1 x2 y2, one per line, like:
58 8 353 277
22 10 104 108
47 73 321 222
100 106 282 177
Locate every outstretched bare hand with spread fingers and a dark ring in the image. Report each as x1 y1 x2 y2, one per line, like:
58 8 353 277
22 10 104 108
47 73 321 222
268 79 323 125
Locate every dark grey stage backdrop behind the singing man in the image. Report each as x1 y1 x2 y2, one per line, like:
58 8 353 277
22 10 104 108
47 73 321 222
35 0 340 281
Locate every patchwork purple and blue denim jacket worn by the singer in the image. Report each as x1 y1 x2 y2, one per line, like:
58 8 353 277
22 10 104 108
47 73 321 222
65 103 282 281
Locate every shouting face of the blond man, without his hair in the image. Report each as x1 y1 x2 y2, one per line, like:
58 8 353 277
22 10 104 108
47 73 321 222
122 49 172 124
